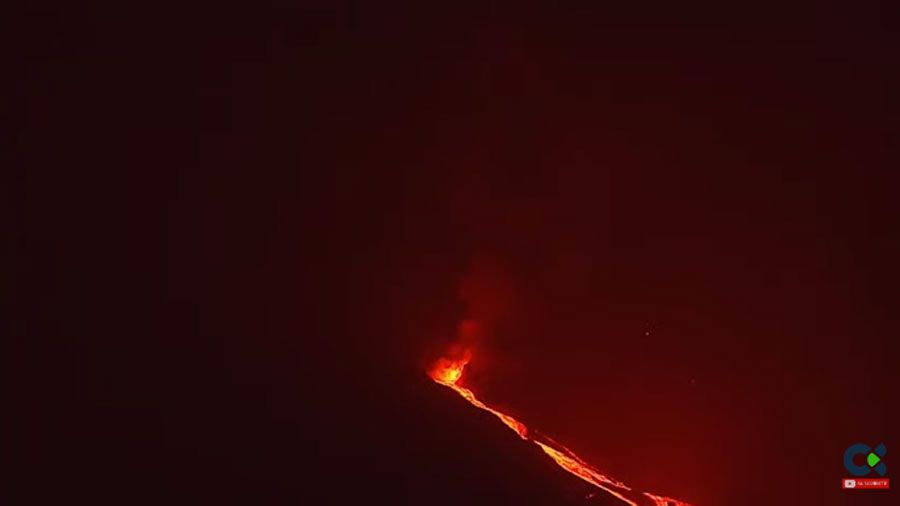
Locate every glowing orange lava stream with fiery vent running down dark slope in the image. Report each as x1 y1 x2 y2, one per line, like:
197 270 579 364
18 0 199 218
429 356 690 506
